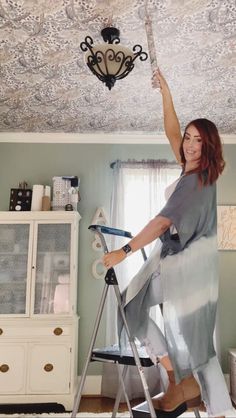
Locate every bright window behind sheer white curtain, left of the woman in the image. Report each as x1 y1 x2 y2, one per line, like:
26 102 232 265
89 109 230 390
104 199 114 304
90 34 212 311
111 160 181 286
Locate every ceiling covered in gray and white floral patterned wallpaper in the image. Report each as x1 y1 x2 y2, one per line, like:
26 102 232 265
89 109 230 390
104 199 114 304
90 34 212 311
0 0 236 134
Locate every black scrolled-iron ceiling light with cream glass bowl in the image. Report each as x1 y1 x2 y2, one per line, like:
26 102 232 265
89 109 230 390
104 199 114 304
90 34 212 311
80 27 148 90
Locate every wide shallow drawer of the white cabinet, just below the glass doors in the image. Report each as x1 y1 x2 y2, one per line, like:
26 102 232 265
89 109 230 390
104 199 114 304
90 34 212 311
0 324 71 341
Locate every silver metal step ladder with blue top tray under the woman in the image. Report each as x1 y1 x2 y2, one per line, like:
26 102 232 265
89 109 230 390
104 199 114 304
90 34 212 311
71 225 201 418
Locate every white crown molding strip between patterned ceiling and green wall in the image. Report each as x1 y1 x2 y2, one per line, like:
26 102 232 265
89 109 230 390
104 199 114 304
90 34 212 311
0 132 236 145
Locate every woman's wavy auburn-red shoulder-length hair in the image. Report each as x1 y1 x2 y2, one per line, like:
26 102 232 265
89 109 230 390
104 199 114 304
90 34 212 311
180 118 225 185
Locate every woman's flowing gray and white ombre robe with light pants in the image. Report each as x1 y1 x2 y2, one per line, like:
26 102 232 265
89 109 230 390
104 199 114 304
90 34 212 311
118 173 232 415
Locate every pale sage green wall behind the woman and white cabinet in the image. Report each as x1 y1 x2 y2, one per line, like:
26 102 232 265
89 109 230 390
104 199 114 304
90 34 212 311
0 143 236 375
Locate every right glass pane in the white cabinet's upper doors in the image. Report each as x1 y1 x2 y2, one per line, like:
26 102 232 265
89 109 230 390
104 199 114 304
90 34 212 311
34 223 71 314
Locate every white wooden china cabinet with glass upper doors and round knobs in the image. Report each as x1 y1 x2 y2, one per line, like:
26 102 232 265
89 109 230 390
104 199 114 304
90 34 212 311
0 211 80 410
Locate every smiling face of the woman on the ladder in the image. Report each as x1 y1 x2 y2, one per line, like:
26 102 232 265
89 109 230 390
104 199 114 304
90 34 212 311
183 125 202 163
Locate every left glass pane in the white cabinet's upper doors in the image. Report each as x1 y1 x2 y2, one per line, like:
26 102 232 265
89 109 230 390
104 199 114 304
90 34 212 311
0 223 30 315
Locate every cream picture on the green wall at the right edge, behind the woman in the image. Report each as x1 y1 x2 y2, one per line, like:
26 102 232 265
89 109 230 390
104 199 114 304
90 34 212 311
217 205 236 250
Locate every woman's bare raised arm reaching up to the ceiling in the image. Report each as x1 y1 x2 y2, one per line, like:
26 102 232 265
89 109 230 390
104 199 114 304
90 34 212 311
152 69 182 164
